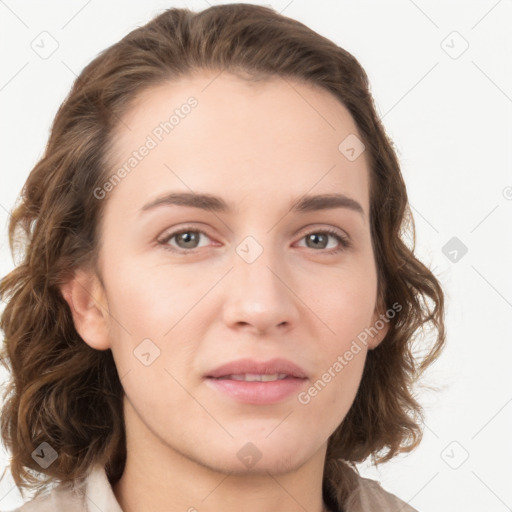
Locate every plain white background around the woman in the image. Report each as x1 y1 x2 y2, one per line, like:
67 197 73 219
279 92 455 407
0 0 512 512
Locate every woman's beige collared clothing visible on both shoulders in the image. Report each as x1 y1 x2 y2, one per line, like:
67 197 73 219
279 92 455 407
6 465 418 512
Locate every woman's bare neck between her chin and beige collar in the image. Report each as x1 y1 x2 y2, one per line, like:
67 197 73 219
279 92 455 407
112 400 327 512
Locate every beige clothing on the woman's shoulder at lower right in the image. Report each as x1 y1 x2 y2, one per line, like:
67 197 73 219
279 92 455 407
347 475 418 512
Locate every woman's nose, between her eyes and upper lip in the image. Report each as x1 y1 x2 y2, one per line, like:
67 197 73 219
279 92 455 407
223 244 300 334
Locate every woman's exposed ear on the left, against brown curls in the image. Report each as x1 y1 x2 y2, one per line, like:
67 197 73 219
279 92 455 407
60 269 110 350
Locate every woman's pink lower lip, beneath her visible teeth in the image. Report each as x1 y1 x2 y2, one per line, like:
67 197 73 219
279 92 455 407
206 377 307 405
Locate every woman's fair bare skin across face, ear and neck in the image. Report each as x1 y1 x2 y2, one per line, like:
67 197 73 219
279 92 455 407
63 71 387 512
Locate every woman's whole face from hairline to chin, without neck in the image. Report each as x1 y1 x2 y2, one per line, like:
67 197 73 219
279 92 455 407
87 72 385 472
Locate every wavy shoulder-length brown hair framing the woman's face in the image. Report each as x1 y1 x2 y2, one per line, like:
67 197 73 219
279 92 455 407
0 4 445 506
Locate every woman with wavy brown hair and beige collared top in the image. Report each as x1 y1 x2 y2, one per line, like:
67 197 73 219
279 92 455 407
1 4 444 512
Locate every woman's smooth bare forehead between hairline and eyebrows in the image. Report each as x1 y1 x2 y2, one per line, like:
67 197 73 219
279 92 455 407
106 71 368 216
